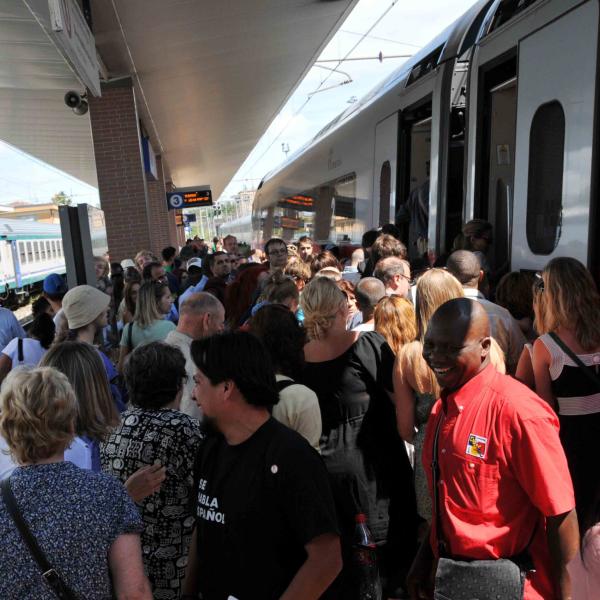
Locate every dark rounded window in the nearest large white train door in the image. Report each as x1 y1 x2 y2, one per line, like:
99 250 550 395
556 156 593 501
526 100 565 254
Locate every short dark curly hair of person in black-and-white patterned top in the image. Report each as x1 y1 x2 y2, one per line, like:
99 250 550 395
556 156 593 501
124 342 187 410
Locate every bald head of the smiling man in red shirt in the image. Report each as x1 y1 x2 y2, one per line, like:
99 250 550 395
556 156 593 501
423 298 491 390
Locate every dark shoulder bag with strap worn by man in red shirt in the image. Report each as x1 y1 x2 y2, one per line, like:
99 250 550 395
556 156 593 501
431 414 537 600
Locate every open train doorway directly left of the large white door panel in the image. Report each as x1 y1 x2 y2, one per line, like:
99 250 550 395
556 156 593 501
474 53 517 271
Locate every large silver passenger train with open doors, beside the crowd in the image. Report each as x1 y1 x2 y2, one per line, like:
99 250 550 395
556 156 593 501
248 0 600 273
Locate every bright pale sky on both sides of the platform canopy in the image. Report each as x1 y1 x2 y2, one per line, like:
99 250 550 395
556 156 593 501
0 0 475 205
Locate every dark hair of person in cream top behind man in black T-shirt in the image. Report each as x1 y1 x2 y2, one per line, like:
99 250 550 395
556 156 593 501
250 304 306 379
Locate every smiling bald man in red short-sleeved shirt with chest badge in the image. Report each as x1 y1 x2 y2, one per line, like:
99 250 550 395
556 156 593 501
408 298 579 600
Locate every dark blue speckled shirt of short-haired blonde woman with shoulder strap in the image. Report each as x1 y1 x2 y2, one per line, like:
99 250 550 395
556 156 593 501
0 462 143 600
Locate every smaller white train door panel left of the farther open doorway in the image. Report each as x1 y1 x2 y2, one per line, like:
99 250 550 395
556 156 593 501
372 113 398 227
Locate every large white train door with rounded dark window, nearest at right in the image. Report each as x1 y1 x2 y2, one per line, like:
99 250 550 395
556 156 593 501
512 0 599 269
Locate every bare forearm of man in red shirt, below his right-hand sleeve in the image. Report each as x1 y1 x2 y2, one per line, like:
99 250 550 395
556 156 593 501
546 509 579 600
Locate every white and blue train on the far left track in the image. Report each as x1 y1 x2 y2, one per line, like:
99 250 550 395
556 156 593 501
0 219 66 303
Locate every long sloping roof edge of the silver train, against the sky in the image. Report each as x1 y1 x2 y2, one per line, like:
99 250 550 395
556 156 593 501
259 0 495 189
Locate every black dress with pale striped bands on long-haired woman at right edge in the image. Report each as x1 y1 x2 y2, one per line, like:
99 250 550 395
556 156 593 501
539 334 600 516
